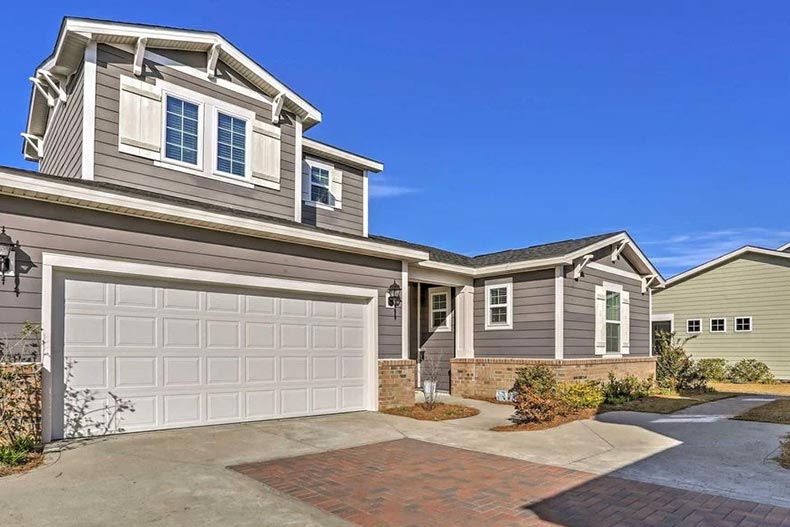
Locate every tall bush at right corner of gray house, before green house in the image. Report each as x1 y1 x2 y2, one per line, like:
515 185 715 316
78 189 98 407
655 333 709 392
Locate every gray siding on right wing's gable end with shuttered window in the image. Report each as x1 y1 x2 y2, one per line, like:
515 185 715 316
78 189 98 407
563 248 650 359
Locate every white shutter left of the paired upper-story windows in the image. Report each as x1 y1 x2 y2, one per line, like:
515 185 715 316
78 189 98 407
118 76 162 159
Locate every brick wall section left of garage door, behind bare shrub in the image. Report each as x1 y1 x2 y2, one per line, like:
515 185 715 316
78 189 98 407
0 362 41 444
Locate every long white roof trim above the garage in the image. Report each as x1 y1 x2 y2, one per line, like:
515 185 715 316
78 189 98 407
0 171 428 261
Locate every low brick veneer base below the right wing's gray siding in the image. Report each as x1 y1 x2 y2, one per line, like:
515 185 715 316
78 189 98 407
450 357 656 397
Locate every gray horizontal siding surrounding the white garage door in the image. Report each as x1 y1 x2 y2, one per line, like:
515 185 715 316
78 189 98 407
0 196 402 358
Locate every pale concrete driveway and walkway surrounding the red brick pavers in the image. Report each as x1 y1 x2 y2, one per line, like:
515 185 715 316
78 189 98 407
0 397 790 526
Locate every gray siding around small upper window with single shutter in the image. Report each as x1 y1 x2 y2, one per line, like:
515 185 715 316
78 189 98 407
302 159 366 234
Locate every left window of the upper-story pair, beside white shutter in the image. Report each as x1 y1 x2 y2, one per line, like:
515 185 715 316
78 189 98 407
165 95 201 166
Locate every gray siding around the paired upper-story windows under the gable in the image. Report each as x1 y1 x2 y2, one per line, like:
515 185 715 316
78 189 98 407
94 44 295 219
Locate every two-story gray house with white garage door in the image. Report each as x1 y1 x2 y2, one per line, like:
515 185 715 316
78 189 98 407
0 18 663 440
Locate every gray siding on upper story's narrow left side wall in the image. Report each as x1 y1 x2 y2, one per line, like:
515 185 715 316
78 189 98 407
39 62 85 178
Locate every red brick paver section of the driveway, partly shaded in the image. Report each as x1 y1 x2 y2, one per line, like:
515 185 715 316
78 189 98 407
234 439 790 527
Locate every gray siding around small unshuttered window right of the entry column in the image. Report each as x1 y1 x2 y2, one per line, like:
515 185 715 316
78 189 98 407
474 269 554 359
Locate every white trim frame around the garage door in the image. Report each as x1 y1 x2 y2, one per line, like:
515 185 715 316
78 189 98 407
41 253 378 442
